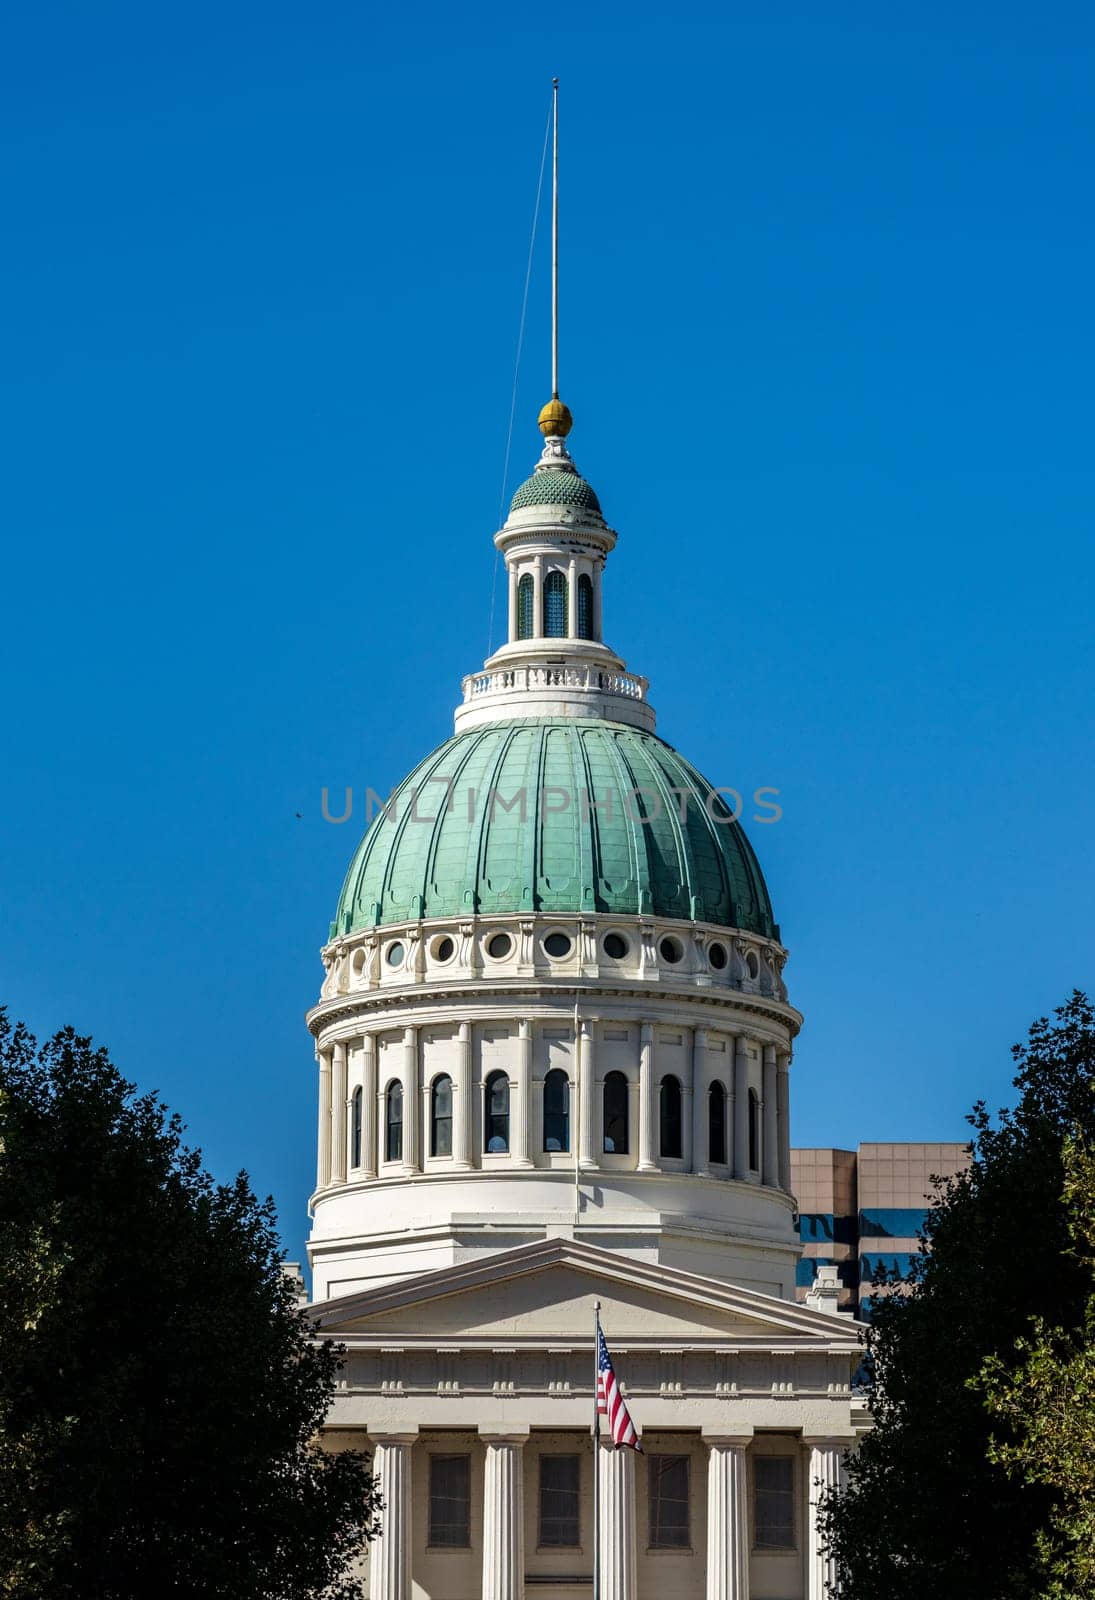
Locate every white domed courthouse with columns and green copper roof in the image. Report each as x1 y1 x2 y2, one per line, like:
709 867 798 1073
309 400 863 1600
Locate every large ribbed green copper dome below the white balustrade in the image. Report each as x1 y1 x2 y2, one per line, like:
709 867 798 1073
331 717 778 938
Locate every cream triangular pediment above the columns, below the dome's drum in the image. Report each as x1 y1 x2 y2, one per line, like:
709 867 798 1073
311 1238 856 1349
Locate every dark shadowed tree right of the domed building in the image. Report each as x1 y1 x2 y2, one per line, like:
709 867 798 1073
824 992 1095 1600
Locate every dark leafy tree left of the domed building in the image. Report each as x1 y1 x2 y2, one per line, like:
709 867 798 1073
0 1011 378 1600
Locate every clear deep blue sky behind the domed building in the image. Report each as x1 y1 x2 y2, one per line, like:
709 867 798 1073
0 3 1095 1273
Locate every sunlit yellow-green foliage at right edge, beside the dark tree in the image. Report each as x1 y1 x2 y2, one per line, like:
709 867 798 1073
977 1138 1095 1600
